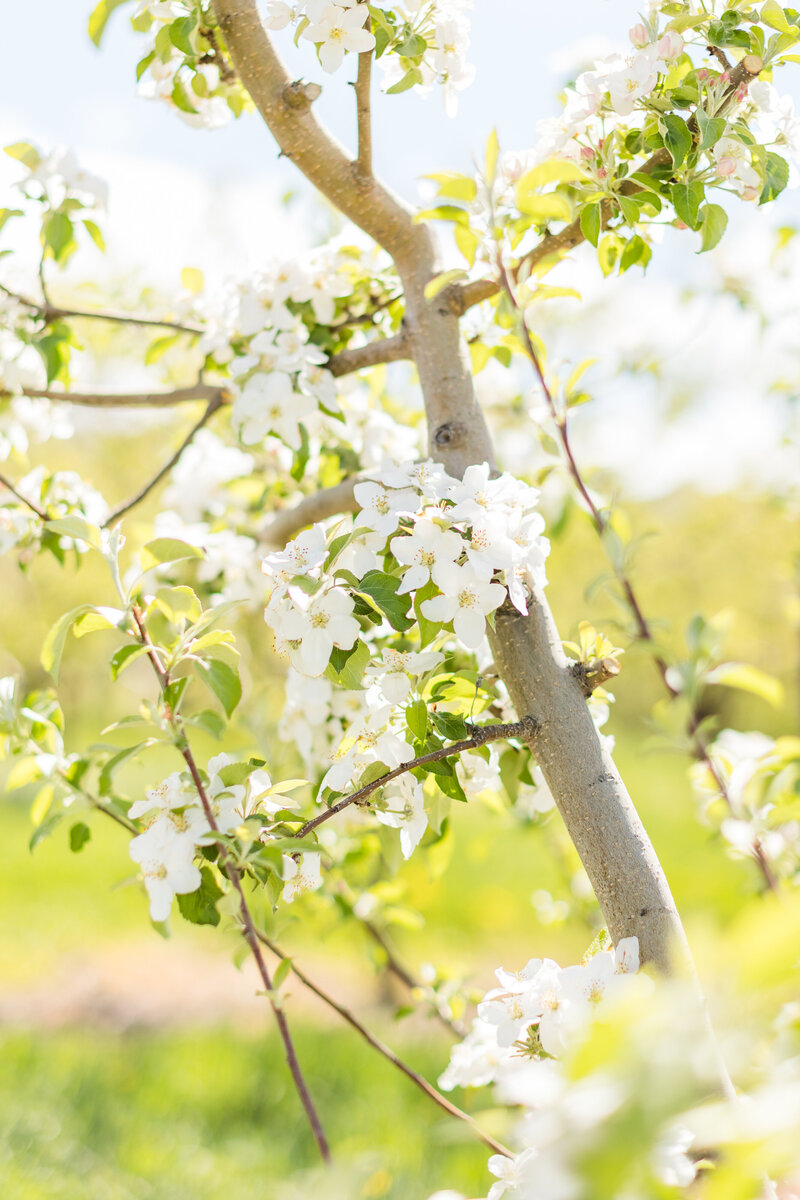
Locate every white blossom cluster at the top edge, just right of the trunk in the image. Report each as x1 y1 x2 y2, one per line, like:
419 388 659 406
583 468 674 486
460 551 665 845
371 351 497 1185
264 0 475 115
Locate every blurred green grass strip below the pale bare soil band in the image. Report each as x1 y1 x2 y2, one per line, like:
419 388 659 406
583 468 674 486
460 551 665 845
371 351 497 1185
0 1030 489 1200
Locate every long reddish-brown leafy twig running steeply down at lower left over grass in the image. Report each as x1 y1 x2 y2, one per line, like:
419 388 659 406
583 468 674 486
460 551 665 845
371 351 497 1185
131 605 331 1163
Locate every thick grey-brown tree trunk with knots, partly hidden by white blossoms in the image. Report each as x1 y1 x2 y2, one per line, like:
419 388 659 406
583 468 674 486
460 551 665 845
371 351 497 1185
215 0 685 971
